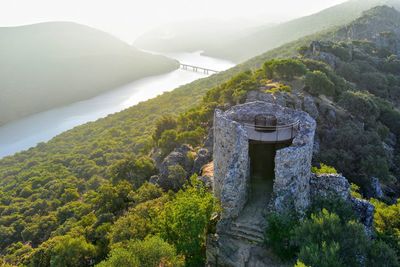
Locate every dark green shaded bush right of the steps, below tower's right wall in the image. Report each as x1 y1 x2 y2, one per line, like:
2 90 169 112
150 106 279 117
265 213 299 260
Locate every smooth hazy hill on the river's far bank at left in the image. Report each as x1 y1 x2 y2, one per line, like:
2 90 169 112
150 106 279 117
0 22 177 125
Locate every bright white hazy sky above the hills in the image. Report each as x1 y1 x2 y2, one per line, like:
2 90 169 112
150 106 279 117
0 0 345 42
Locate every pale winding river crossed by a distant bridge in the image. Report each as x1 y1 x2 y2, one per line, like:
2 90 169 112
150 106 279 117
0 52 234 158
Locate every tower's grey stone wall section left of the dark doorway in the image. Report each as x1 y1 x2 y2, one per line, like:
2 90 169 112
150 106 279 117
213 110 250 219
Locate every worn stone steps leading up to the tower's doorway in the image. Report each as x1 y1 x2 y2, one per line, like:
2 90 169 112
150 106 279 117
225 222 264 245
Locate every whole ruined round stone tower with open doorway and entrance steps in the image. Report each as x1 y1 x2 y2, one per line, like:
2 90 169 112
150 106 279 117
207 101 316 266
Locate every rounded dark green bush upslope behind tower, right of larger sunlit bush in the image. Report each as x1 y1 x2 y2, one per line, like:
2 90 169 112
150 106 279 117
305 70 335 96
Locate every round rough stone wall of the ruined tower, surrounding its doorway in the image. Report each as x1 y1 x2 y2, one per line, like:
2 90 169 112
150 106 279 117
213 101 316 219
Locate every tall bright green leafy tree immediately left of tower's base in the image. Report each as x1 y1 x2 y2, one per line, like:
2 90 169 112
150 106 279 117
160 179 216 266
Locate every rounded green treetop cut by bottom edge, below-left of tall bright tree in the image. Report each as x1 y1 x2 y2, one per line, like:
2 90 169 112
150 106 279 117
96 236 184 267
